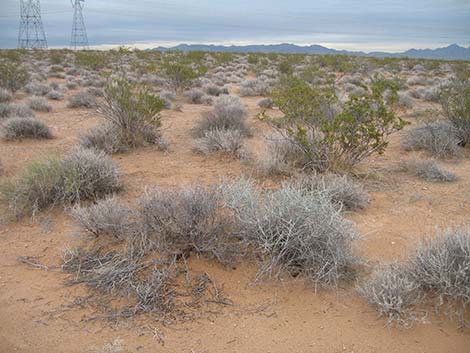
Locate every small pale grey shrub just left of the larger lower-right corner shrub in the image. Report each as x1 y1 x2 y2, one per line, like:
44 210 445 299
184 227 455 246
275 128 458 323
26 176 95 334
357 263 423 326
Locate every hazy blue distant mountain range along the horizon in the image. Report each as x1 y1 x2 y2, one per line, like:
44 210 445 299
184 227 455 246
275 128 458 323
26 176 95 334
153 43 470 60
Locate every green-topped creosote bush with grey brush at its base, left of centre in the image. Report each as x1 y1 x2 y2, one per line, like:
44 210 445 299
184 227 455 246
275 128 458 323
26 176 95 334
81 79 168 153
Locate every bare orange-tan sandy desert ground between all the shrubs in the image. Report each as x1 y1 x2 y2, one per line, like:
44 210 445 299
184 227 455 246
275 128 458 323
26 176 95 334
0 50 470 353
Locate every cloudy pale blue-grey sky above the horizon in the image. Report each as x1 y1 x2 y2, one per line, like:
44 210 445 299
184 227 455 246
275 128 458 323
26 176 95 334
0 0 470 51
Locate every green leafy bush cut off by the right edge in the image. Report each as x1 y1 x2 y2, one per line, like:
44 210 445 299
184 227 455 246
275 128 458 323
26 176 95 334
440 79 470 146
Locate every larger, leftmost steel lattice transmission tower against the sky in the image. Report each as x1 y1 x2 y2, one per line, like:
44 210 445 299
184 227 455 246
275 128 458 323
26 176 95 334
18 0 47 49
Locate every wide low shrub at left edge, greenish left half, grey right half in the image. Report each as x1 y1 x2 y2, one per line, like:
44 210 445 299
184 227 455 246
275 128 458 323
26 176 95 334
1 149 122 217
